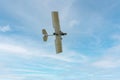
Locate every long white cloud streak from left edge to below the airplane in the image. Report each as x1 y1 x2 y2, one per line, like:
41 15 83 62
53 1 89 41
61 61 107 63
0 41 88 63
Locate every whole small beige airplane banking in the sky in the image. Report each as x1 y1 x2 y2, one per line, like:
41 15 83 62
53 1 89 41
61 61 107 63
42 11 67 53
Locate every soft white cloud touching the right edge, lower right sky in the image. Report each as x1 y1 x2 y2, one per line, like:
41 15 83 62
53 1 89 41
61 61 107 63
92 45 120 69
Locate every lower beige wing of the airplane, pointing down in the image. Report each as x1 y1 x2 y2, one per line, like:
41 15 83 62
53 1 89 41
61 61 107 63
55 36 62 53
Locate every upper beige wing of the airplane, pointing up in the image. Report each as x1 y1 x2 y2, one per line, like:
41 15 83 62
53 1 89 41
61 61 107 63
52 11 60 33
